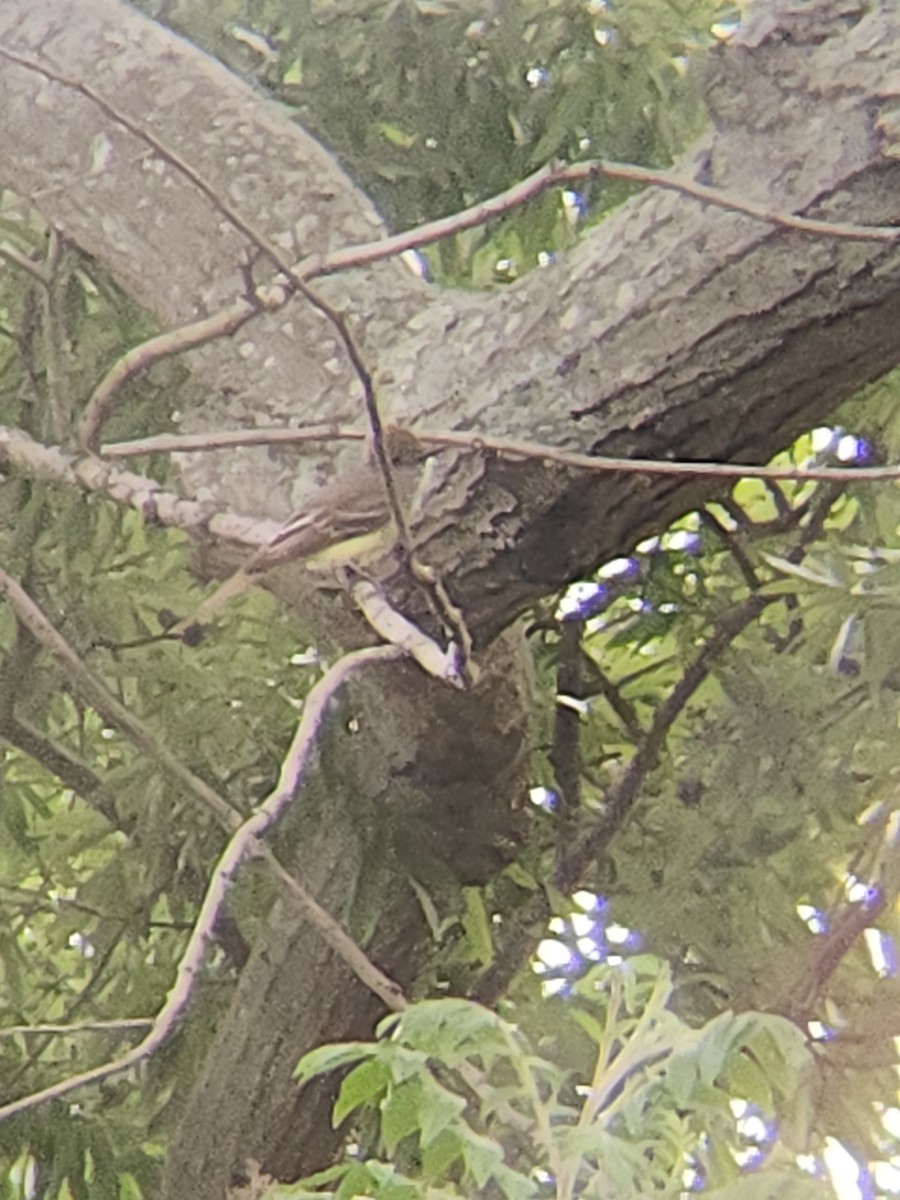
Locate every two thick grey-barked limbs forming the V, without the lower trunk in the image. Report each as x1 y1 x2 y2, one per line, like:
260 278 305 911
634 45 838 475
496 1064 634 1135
0 0 900 600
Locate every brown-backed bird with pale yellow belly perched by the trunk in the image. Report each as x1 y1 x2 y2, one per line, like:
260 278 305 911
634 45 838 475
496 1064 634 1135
178 426 433 635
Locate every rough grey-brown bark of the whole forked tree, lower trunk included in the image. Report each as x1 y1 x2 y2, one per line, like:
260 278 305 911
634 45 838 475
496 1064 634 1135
0 0 900 1200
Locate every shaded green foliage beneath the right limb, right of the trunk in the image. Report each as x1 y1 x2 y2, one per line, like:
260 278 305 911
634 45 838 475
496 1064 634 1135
516 403 900 1180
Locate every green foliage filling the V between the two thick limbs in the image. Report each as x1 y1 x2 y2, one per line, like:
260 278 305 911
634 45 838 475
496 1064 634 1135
133 0 727 278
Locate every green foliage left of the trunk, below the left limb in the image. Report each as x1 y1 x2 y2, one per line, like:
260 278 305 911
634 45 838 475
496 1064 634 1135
0 211 321 1198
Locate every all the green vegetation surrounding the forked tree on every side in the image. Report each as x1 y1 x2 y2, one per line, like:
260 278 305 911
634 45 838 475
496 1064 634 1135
0 0 900 1200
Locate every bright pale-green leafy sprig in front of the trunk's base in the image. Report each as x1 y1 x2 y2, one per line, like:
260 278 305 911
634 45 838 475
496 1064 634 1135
292 956 820 1200
